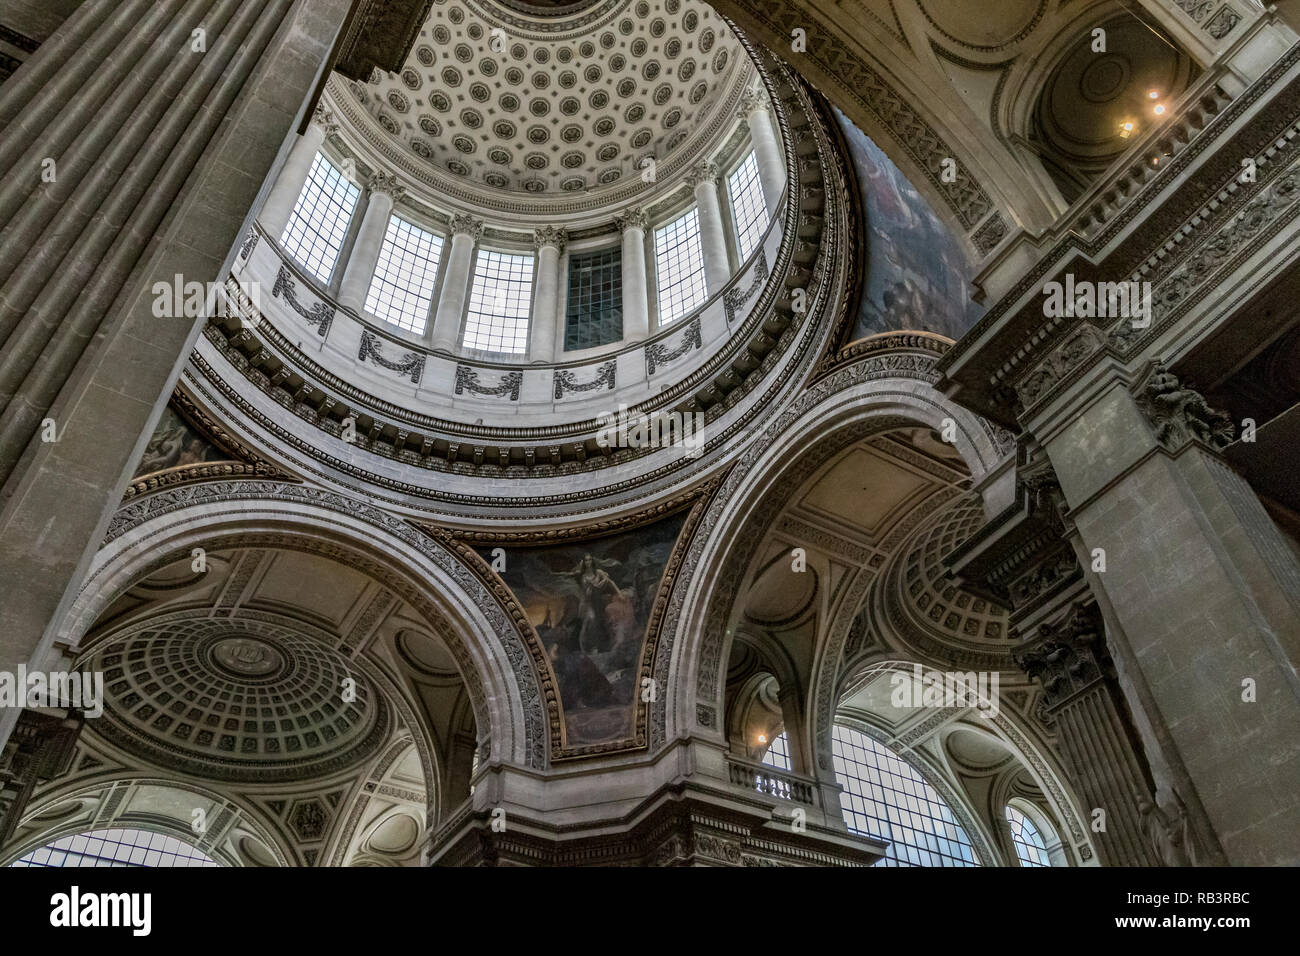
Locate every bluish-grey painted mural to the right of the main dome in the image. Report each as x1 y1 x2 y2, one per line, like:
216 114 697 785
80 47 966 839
836 112 983 342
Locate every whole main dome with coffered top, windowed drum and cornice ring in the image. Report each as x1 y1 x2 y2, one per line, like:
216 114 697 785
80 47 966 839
195 0 852 520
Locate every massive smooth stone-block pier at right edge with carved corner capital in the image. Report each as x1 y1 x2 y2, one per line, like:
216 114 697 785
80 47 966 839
1045 364 1300 866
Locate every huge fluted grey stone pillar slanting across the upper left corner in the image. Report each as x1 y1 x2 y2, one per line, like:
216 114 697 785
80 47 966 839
0 0 351 740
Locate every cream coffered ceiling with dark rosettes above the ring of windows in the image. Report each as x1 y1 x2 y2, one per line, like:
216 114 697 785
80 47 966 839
335 0 751 200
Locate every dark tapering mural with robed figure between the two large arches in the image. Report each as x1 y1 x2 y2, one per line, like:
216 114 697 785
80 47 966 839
481 511 688 748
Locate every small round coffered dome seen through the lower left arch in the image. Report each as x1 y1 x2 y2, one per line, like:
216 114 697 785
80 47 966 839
90 611 389 780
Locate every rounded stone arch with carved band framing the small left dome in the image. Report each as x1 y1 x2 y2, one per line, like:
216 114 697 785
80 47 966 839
59 481 546 767
